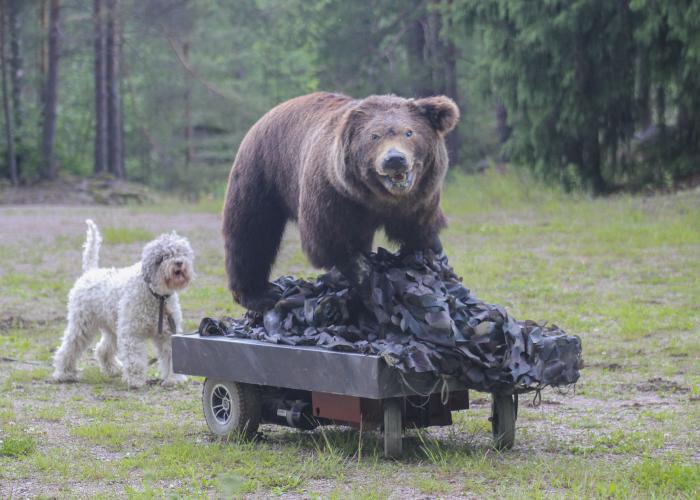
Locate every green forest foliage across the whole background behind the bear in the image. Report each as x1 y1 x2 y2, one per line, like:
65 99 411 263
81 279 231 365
0 0 700 193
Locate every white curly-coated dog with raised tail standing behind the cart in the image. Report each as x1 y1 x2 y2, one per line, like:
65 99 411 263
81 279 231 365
53 219 195 388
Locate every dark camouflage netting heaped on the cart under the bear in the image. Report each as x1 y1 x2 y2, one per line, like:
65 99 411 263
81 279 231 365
199 248 582 392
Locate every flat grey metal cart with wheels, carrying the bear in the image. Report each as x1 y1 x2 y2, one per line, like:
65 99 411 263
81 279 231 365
172 334 518 458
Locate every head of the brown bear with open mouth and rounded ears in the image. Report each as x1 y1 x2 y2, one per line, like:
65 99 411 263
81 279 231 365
337 96 459 201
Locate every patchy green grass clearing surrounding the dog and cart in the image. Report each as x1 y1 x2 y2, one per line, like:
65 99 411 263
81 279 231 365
0 173 700 498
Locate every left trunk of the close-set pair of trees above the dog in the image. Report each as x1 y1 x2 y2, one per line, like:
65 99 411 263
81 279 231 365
93 0 108 174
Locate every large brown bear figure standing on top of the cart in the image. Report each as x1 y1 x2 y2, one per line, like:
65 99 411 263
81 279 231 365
223 92 459 311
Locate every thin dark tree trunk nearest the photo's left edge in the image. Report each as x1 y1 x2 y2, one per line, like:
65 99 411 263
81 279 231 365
8 0 24 177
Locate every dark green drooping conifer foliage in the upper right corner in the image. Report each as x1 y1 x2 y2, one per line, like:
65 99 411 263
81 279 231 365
460 0 700 194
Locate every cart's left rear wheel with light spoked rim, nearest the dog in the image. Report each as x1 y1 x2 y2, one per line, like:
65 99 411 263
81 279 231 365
202 379 261 438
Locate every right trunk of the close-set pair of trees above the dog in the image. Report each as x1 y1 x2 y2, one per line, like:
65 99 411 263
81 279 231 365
106 0 126 179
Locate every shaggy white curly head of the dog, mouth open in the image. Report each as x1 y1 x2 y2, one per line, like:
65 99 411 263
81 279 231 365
141 231 195 295
